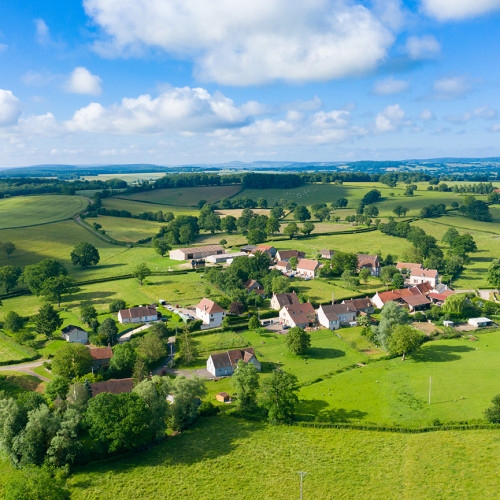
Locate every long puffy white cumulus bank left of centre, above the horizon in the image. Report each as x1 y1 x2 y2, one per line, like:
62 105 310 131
67 87 259 134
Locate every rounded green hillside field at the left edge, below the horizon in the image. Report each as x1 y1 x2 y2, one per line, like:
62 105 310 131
0 195 88 229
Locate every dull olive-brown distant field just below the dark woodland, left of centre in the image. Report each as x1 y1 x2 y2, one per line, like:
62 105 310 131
120 185 241 207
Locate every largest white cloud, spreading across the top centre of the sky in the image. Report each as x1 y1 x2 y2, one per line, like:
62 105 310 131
84 0 394 85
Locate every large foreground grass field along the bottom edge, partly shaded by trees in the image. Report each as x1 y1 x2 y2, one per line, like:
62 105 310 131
58 417 500 500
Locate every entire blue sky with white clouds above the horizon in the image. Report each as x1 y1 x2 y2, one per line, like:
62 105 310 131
0 0 500 167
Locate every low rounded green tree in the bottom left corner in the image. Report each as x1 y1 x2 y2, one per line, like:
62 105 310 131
4 466 70 500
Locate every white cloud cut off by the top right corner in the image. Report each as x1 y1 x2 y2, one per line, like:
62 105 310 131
422 0 500 21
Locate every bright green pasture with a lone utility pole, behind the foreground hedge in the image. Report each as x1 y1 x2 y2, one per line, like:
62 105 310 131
299 330 500 425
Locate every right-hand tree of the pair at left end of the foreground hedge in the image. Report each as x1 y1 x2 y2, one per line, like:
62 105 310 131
262 369 299 424
